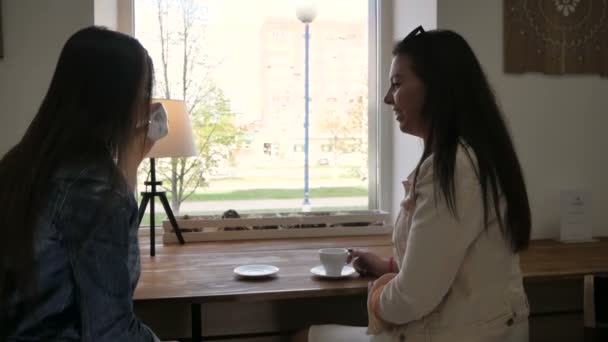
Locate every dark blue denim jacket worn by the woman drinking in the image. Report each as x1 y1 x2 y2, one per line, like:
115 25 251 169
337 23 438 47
2 163 158 342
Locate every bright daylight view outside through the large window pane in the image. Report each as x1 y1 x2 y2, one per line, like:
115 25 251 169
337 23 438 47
135 0 369 225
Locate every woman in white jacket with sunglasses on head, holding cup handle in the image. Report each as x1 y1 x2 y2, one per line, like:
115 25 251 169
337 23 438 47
299 27 531 342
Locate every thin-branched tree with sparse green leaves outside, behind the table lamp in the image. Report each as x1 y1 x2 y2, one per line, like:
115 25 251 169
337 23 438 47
141 0 238 214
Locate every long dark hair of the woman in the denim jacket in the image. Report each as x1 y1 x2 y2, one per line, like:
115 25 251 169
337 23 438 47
0 27 153 312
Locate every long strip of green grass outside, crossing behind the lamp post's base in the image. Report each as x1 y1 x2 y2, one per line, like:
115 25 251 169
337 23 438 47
173 186 368 202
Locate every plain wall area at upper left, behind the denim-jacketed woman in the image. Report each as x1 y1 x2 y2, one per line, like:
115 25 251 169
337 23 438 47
0 0 93 156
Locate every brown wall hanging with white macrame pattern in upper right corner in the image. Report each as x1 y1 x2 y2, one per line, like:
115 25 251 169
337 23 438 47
504 0 608 77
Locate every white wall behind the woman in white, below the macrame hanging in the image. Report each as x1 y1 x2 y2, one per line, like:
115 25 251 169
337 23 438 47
437 0 608 238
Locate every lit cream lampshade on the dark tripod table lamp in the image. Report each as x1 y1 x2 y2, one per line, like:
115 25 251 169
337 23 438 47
147 99 198 158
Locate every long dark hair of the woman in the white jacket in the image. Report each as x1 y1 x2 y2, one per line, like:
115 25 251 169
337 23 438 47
393 27 531 252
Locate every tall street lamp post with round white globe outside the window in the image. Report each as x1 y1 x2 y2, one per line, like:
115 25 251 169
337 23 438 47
296 0 317 212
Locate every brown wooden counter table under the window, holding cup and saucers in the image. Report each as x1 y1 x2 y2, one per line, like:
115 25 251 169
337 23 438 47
134 236 608 341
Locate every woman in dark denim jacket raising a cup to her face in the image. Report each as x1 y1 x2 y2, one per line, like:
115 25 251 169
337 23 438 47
0 27 157 341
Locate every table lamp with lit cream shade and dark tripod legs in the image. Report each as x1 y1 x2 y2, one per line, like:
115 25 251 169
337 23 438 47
139 99 198 256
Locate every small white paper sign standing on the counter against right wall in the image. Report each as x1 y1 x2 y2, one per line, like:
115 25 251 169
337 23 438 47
560 190 593 242
